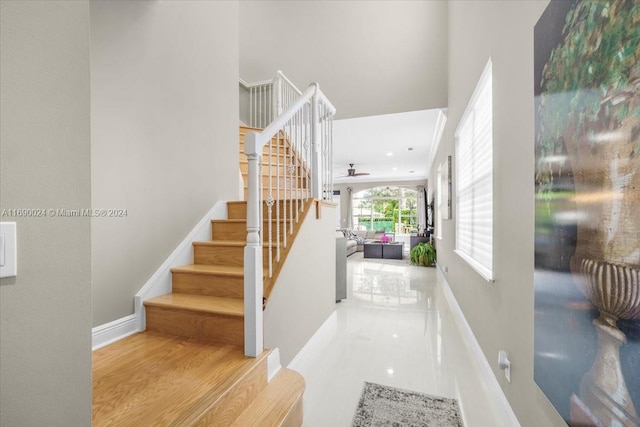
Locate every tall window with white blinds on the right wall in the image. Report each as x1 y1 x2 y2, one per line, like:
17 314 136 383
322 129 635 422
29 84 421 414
455 60 493 280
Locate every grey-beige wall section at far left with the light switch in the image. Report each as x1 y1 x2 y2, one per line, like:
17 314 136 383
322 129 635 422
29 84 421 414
0 1 91 427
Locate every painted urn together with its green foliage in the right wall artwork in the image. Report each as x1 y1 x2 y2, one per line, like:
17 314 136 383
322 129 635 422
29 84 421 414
537 0 640 427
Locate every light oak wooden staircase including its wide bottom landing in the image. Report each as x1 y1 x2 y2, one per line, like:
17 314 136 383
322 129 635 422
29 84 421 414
92 127 311 427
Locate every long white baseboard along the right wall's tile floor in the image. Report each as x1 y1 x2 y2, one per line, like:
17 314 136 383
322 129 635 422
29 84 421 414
436 264 520 427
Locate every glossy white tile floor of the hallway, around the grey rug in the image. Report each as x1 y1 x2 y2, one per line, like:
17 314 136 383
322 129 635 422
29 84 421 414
289 254 512 427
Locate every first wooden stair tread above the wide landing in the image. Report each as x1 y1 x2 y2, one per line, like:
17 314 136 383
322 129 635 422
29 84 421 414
144 293 244 317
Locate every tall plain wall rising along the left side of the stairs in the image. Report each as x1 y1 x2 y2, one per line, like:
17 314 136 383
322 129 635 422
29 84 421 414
91 1 239 326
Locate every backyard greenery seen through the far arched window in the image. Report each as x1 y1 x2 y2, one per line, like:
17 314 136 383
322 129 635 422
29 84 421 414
353 187 418 234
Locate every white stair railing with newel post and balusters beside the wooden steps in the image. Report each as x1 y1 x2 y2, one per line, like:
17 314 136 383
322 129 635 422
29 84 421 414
244 72 336 357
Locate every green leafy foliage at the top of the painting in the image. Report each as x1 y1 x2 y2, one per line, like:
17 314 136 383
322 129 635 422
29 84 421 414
536 0 640 199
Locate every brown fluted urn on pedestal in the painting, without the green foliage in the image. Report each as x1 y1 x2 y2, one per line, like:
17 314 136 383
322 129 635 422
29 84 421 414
565 111 640 426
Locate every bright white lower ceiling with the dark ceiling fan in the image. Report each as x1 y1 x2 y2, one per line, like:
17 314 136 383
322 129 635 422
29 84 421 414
333 109 446 184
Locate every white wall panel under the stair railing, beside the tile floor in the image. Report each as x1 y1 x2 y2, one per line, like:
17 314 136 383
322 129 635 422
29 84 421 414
264 204 336 366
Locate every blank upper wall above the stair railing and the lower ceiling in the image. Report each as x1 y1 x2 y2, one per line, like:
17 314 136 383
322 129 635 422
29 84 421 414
240 0 447 119
